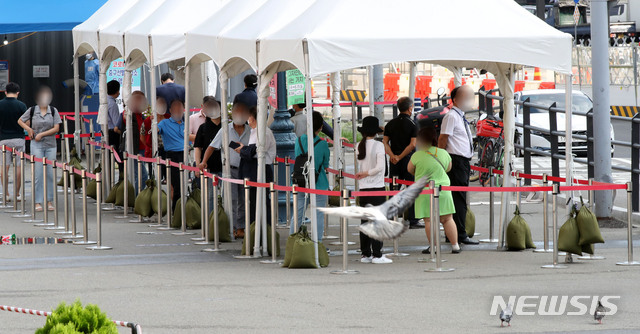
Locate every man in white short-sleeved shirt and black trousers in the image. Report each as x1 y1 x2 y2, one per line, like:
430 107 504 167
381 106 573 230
438 86 478 245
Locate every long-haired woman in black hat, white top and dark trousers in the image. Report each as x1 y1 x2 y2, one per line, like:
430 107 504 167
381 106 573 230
356 116 393 264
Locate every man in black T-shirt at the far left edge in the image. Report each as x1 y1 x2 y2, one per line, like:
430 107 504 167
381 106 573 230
0 82 27 203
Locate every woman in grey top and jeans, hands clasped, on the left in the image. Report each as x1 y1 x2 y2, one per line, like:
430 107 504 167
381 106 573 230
18 86 62 212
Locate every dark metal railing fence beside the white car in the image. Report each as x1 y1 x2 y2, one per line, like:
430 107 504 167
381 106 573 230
478 87 640 212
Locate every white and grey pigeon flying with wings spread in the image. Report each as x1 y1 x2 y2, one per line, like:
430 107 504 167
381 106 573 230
318 176 428 241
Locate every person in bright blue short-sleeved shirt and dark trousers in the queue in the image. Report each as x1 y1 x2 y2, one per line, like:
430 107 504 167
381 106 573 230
158 100 184 210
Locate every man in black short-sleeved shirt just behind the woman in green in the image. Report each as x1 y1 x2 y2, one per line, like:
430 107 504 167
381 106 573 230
382 96 424 228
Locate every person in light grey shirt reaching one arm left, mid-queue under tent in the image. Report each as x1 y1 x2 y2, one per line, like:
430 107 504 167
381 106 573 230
198 103 251 239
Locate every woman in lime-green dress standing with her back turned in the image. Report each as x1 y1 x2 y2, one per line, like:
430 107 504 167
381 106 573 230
407 127 460 254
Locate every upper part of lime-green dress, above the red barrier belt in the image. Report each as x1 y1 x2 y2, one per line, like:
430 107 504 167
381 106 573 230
411 146 451 186
